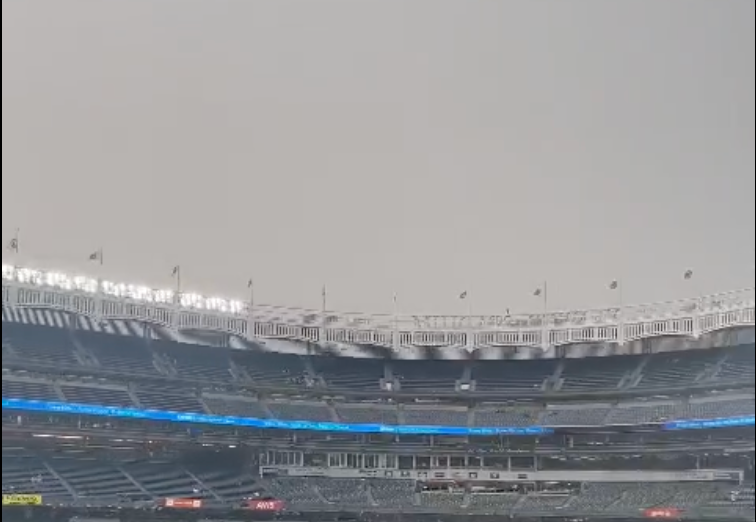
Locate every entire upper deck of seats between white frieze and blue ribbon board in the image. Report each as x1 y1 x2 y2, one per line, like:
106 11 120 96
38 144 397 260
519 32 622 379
3 323 755 428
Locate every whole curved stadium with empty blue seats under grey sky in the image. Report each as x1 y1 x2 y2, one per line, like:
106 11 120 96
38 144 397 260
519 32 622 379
3 265 756 521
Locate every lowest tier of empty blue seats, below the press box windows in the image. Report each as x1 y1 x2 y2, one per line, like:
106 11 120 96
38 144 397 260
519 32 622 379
2 448 754 516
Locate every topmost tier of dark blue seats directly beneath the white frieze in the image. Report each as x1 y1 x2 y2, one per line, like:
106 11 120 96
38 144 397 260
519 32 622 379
3 323 756 394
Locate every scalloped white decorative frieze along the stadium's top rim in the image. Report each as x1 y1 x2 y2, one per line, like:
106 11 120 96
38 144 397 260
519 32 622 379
2 264 754 359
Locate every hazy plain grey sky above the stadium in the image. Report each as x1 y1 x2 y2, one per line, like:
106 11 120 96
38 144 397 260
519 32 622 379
2 0 756 313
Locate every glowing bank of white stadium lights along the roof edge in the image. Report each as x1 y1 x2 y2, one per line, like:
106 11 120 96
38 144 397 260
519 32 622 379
3 264 249 315
